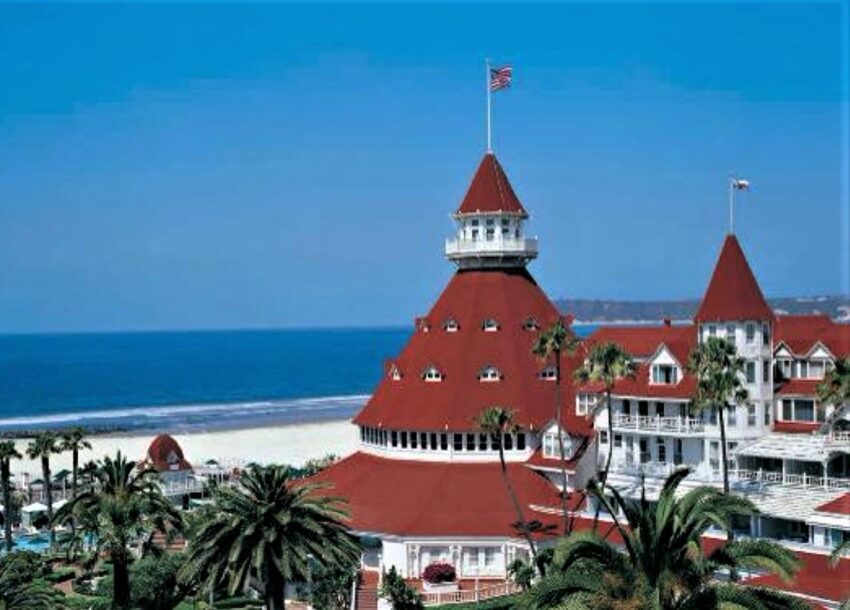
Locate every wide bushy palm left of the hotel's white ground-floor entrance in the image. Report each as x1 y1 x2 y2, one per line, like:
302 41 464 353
181 466 360 610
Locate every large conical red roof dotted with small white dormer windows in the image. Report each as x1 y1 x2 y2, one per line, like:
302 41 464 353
354 269 591 435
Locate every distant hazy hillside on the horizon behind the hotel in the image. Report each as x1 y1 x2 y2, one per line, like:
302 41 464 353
555 296 850 322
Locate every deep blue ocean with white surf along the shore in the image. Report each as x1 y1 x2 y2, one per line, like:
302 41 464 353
0 326 593 433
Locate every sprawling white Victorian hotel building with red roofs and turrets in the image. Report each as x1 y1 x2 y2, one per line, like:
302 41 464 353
316 154 850 607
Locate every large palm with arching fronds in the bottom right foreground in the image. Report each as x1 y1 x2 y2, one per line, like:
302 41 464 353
527 468 809 610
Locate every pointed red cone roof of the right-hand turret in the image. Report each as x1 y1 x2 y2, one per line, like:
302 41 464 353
694 234 773 322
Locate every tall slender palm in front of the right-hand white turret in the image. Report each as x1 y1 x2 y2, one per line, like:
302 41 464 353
687 337 748 494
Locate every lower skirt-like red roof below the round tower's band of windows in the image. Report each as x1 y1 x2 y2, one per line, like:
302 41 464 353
311 453 560 536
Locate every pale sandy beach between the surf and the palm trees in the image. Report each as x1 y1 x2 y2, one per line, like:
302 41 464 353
4 420 357 478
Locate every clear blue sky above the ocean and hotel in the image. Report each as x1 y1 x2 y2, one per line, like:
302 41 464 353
0 2 850 332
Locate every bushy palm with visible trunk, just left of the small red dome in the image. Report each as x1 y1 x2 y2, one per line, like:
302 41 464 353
55 451 182 610
